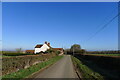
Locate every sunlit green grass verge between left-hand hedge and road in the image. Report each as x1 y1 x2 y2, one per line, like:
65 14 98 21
2 56 63 80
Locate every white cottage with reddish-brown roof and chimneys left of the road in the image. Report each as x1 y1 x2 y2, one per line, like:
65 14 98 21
34 42 50 54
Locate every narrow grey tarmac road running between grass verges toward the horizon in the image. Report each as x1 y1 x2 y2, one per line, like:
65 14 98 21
34 55 78 80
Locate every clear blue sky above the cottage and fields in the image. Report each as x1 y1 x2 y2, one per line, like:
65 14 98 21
2 2 118 50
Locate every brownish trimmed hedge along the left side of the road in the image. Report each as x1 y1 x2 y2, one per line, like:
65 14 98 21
2 54 56 75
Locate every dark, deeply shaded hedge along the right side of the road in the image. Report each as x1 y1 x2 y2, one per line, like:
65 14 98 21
75 54 120 79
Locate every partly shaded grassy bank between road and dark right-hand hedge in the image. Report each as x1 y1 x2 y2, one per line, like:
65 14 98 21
71 56 104 80
